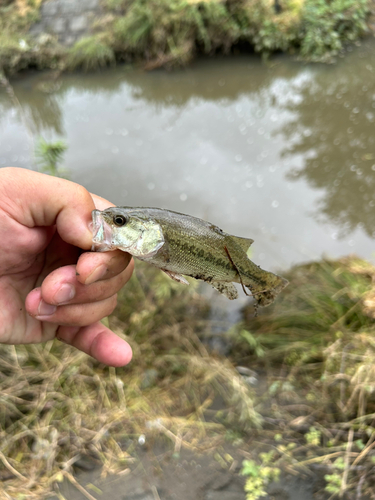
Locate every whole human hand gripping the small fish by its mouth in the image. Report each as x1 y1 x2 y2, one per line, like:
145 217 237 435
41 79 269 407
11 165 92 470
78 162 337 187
0 168 133 366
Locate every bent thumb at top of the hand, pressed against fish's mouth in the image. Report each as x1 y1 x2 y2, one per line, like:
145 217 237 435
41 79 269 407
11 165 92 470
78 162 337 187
0 167 95 250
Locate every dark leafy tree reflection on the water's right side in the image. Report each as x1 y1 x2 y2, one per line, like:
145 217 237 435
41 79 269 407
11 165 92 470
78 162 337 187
280 53 375 237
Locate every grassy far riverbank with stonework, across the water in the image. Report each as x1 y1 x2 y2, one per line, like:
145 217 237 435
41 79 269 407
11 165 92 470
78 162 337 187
0 0 374 74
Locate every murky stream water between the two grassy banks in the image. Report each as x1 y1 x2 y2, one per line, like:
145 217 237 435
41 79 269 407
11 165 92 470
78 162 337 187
0 41 375 286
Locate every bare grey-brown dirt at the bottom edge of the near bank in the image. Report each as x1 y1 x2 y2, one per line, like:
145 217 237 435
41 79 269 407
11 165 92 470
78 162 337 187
51 446 319 500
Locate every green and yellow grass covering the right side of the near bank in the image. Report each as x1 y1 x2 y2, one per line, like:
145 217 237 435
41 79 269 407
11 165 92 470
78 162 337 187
238 257 375 499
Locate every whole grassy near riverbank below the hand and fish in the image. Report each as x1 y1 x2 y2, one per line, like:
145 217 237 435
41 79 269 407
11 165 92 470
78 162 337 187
0 257 375 500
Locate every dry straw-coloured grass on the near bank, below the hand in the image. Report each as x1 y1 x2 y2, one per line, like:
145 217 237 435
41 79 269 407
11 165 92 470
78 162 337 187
0 266 260 499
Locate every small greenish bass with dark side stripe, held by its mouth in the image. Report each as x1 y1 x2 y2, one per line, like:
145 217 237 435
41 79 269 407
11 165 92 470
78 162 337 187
91 207 288 307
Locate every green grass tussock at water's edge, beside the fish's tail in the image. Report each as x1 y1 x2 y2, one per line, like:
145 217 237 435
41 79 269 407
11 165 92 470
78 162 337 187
244 257 375 363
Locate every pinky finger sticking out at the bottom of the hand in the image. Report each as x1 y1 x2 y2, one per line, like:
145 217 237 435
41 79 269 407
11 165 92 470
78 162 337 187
56 322 132 367
